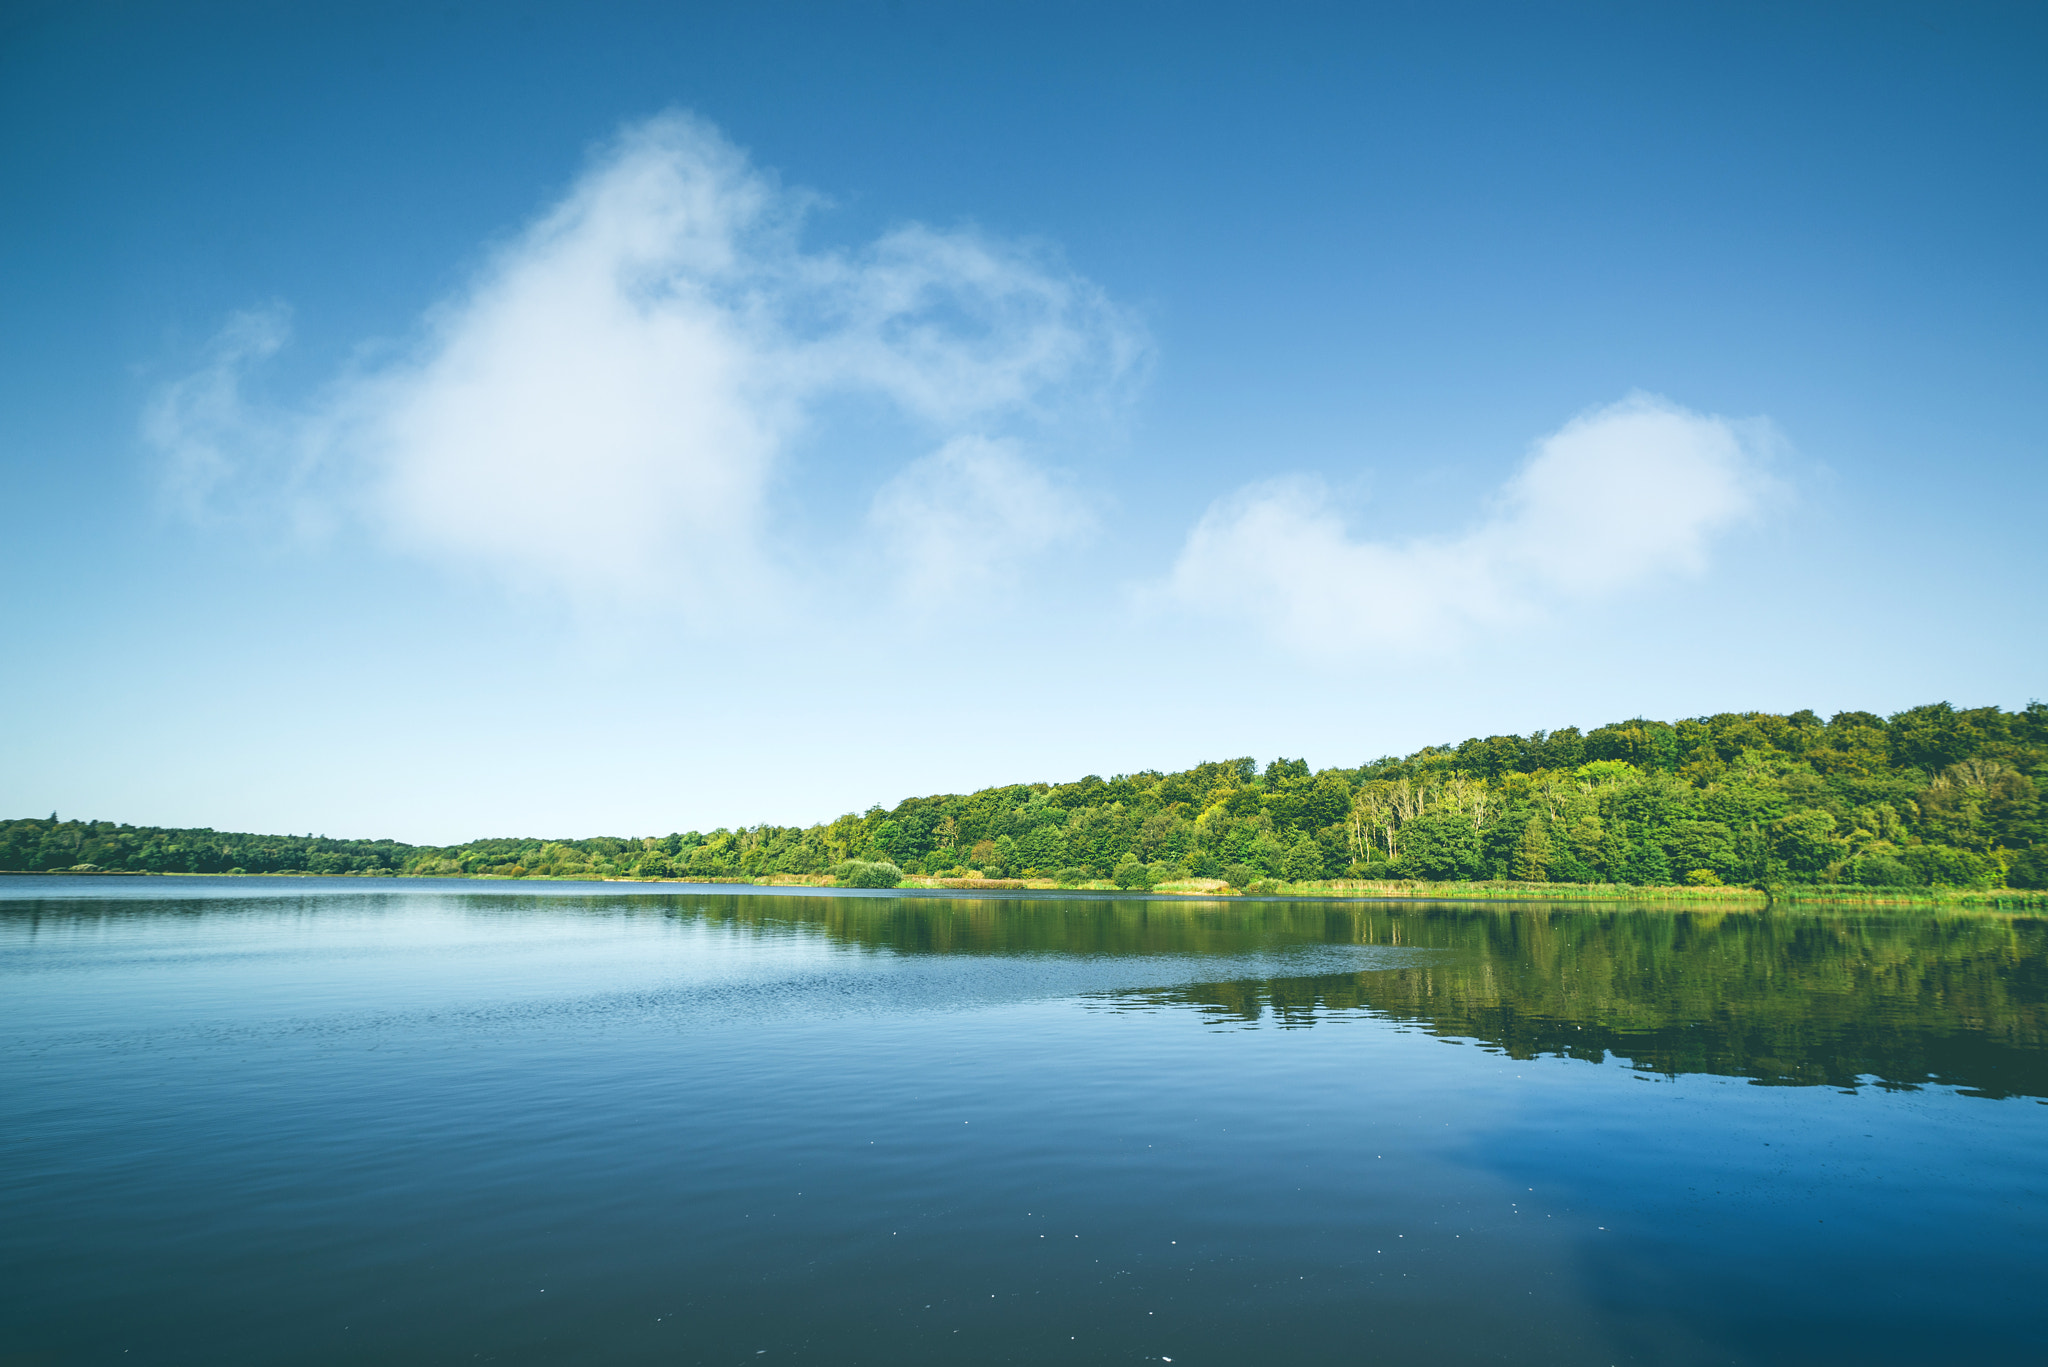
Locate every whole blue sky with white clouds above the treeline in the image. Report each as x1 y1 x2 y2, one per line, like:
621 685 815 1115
0 4 2048 840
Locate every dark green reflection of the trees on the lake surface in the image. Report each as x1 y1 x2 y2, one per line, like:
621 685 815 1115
692 896 2048 1096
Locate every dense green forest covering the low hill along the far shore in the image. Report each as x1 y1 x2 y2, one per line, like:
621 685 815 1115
0 703 2048 887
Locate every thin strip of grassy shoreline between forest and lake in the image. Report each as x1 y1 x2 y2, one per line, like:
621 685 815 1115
12 869 2048 912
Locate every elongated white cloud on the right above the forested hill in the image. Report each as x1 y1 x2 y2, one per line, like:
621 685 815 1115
1165 393 1778 656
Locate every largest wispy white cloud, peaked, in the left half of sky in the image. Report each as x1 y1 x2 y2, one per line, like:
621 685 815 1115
145 115 1143 607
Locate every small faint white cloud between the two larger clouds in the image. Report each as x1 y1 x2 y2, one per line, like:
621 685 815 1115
868 437 1094 605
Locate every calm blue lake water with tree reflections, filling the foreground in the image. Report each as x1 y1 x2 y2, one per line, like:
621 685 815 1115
0 877 2048 1367
